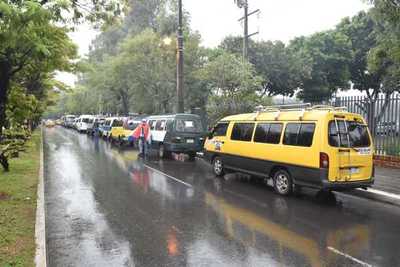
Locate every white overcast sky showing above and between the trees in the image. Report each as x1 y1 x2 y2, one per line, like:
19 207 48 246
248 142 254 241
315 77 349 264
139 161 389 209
59 0 368 85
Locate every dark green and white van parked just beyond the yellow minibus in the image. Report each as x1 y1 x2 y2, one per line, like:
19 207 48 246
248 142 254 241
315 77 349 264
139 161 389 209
147 113 206 160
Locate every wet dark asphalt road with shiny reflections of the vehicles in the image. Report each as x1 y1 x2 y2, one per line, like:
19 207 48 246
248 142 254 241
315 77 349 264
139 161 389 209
44 127 400 267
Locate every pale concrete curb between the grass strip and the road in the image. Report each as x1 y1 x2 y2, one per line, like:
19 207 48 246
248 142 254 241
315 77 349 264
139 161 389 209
35 127 47 267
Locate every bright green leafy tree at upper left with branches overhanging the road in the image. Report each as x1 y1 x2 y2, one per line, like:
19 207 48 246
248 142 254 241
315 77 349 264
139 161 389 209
0 0 123 136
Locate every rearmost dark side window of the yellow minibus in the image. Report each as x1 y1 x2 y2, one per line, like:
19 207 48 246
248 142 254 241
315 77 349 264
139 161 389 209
283 123 315 147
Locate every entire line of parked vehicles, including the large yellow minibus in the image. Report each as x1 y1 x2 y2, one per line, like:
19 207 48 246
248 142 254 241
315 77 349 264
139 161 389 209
57 105 374 198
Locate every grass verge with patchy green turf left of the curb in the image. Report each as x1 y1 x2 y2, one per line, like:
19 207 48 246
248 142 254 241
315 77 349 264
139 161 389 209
0 130 42 267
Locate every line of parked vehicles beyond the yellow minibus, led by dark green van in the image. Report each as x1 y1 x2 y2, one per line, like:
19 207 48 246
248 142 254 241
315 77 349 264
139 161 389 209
61 114 206 160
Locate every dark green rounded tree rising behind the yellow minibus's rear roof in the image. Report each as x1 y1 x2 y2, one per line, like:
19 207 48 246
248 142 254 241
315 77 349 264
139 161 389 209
289 30 353 102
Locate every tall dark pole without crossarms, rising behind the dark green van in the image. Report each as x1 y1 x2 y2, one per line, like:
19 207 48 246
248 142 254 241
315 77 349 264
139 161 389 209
176 0 185 113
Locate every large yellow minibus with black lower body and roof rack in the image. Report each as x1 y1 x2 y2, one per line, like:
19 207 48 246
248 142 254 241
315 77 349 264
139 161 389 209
204 105 374 195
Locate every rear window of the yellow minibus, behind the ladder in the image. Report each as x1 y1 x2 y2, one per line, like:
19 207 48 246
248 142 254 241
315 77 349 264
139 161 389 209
329 120 371 147
